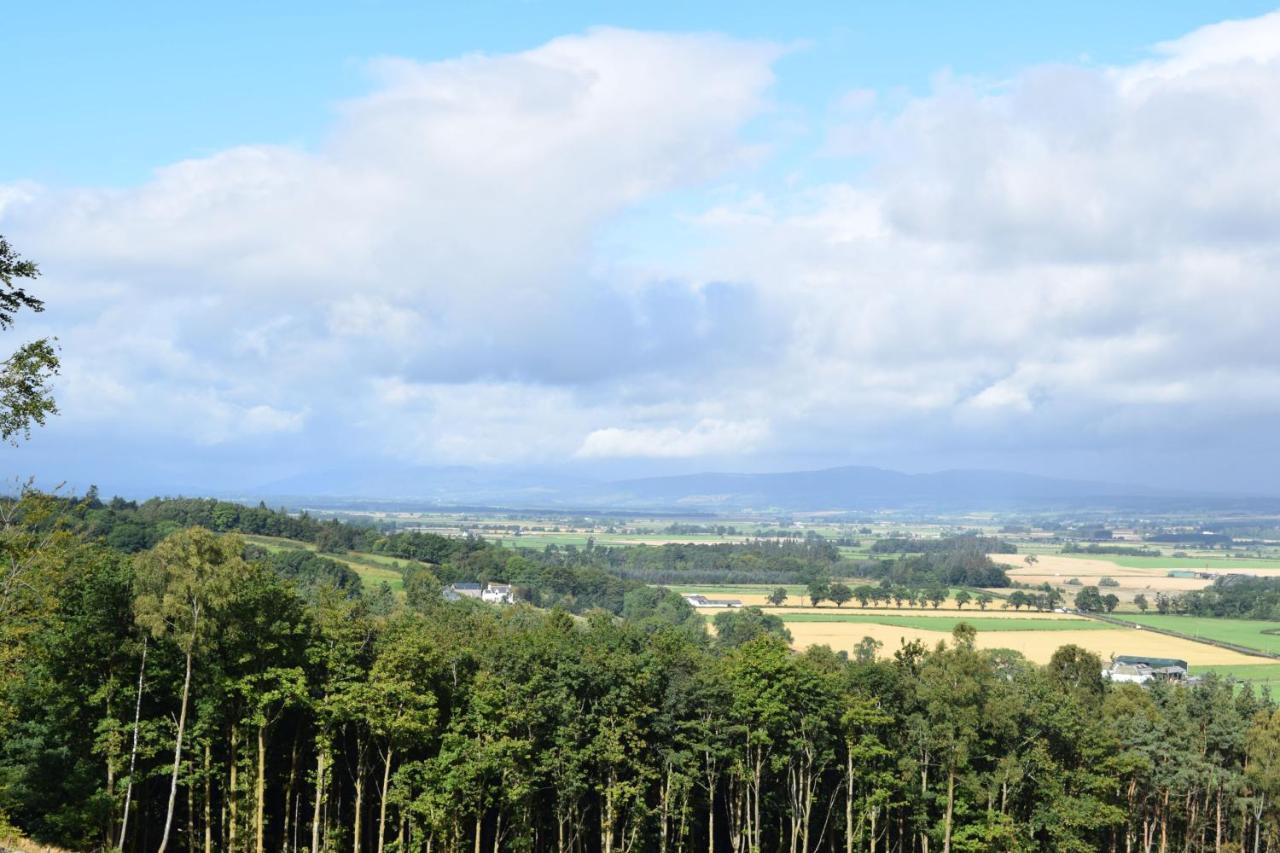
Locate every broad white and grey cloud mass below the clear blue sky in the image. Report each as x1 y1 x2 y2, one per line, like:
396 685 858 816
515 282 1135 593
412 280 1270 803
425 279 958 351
0 14 1280 482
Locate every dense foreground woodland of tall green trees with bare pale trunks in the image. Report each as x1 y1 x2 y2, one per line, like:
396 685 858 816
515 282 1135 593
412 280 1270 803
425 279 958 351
12 494 1280 853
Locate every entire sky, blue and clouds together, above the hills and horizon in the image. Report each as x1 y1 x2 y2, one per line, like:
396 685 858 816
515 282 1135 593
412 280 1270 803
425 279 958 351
0 0 1280 494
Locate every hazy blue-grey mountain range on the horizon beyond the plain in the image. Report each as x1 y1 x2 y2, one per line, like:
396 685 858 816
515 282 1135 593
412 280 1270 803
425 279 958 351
240 466 1257 511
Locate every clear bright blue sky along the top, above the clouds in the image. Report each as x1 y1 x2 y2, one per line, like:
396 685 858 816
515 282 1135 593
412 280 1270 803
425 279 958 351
0 0 1272 184
